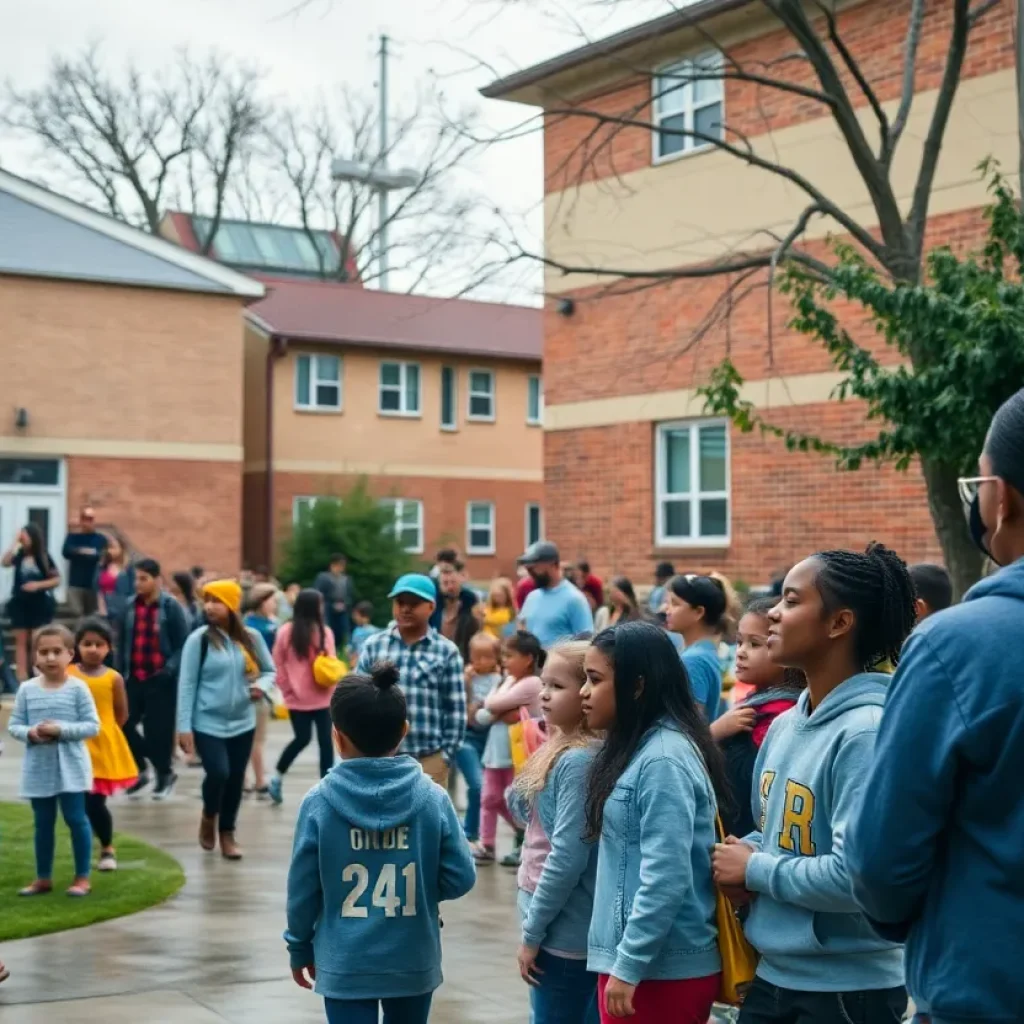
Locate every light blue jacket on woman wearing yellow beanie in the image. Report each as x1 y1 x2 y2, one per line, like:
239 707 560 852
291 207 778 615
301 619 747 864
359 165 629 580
178 626 276 738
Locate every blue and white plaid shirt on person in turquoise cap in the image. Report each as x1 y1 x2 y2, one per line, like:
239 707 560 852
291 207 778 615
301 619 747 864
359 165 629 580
356 626 466 762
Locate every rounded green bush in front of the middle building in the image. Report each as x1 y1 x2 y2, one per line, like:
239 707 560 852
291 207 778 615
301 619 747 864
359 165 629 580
279 480 417 626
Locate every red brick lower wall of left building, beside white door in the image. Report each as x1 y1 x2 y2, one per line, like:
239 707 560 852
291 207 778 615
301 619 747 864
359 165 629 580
68 457 242 573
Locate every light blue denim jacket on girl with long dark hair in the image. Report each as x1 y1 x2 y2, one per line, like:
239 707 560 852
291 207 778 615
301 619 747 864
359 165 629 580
587 723 722 985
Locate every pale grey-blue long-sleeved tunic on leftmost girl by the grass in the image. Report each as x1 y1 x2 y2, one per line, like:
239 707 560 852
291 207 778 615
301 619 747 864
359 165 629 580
7 678 99 800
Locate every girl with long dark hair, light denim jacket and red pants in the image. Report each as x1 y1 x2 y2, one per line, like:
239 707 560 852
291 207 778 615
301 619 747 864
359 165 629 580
583 622 727 1024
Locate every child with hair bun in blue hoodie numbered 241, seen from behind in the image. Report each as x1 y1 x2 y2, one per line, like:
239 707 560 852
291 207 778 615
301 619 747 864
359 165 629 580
285 663 476 1024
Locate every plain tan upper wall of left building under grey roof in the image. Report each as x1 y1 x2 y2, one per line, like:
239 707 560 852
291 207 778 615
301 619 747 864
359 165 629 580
0 276 243 462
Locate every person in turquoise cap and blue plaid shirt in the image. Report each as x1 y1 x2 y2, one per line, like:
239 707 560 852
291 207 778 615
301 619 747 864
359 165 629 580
356 572 466 786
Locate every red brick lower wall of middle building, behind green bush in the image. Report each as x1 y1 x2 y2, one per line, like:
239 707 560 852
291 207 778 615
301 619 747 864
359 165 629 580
270 472 544 580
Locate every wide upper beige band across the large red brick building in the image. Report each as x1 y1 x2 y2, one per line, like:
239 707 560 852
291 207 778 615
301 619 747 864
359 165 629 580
545 70 1018 293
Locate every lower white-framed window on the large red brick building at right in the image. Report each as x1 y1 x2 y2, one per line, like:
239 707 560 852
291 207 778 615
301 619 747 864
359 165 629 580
654 420 730 548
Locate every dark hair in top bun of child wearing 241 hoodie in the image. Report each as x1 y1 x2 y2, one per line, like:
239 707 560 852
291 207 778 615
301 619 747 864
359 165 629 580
331 662 409 758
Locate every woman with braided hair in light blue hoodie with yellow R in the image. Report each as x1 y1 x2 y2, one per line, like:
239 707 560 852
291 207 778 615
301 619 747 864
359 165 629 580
714 544 915 1024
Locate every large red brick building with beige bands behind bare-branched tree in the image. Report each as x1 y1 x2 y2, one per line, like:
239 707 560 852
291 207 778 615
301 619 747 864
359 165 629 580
484 0 1017 584
